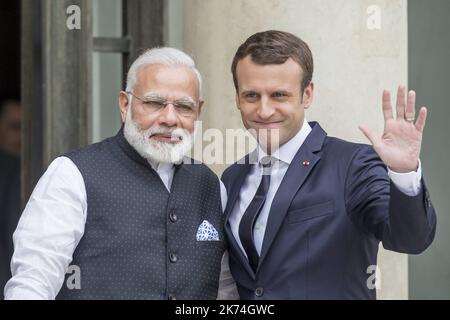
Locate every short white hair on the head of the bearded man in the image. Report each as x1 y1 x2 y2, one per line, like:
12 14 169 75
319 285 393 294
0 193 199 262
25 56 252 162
126 47 203 99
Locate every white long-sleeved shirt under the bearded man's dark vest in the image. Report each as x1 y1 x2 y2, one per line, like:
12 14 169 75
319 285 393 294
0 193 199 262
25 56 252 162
5 157 238 299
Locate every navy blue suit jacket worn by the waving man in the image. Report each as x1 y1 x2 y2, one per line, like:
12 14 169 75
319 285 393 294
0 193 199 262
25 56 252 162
222 122 436 299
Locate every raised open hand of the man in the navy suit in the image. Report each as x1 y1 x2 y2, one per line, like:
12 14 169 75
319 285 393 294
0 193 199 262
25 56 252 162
359 85 427 173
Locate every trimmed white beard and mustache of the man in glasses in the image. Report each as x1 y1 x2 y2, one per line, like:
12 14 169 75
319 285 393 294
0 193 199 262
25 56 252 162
124 108 195 164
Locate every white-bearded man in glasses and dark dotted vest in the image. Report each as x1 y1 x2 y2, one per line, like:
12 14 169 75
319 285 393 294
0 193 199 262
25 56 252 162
5 48 236 299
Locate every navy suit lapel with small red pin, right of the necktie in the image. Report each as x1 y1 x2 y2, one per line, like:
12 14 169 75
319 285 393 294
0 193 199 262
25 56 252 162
257 122 326 272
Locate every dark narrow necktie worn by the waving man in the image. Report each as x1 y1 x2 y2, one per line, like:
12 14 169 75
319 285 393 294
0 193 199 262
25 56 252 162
239 157 271 272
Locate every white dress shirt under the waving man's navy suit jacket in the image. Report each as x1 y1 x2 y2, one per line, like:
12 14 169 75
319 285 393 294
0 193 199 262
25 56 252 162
229 119 422 256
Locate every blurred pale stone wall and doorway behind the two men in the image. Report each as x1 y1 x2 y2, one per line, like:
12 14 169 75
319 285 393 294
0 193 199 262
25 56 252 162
0 0 450 299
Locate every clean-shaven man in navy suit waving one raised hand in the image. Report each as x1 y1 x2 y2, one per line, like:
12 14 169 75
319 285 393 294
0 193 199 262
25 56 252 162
222 31 436 299
